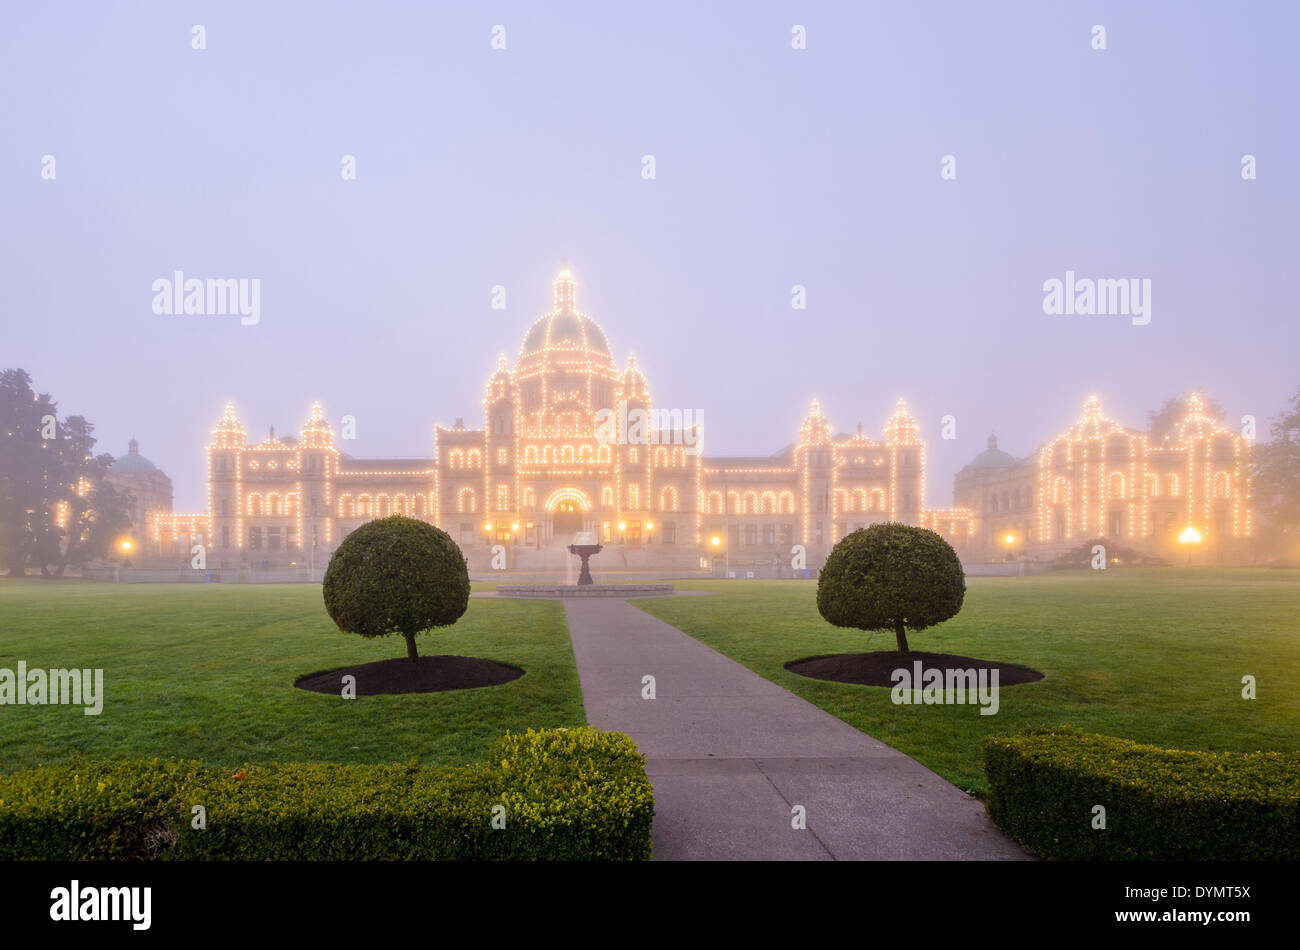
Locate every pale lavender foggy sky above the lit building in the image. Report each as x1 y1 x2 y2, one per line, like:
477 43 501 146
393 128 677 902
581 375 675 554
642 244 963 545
0 3 1300 511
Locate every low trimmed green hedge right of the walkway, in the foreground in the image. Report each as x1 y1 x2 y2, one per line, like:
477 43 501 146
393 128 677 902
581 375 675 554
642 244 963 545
984 726 1300 860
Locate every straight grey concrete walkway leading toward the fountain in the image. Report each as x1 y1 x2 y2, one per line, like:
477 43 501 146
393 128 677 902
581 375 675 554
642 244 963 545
564 600 1026 860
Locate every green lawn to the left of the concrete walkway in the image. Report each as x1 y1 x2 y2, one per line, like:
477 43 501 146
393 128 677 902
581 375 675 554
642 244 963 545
0 580 586 772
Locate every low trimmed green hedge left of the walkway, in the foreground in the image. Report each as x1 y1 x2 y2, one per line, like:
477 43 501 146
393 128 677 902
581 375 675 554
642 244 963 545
0 728 654 860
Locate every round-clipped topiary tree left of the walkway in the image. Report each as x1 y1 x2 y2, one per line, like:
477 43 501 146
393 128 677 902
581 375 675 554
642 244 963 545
324 515 469 661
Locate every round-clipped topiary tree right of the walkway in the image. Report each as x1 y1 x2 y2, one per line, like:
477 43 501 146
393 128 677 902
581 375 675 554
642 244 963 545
816 522 966 654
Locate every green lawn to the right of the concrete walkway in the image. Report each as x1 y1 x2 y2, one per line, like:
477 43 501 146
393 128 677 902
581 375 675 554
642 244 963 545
633 568 1300 793
